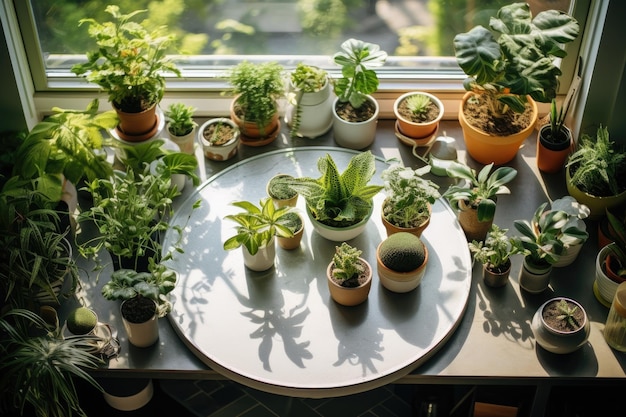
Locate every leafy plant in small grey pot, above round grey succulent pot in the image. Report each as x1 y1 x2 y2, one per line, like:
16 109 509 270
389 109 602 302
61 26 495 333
513 203 589 293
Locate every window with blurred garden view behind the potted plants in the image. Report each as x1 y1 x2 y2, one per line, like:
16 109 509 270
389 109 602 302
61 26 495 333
14 0 590 115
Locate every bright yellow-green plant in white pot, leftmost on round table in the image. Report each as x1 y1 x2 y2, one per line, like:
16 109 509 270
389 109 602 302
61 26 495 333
224 197 293 271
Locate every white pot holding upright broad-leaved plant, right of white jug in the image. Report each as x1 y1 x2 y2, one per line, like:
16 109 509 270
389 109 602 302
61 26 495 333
332 96 380 150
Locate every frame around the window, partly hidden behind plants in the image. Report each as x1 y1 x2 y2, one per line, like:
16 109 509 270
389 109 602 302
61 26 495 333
9 0 597 119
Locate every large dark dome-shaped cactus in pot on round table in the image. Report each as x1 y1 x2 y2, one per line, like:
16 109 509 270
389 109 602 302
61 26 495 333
379 232 426 272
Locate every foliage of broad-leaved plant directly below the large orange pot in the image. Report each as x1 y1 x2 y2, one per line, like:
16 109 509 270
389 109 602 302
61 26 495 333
443 162 517 222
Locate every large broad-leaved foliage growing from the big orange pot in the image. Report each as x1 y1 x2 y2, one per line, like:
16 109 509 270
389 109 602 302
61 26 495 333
454 3 579 117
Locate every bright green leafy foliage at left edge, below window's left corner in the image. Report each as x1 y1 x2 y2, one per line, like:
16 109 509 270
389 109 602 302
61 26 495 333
14 99 117 187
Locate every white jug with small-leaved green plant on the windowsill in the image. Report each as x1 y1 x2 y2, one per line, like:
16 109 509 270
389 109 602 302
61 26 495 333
287 62 333 138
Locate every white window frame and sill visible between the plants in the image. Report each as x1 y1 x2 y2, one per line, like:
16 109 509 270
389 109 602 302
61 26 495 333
3 0 588 128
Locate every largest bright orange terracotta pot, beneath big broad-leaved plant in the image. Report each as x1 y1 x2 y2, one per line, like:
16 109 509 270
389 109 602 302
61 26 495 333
459 91 538 165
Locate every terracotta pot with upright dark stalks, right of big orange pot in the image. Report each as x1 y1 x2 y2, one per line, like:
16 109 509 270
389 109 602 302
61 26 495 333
537 99 574 174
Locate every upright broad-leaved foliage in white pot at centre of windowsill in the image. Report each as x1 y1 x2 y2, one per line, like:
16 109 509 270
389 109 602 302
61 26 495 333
333 39 387 109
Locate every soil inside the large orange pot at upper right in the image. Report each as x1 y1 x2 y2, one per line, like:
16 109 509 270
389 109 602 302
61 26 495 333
463 94 533 136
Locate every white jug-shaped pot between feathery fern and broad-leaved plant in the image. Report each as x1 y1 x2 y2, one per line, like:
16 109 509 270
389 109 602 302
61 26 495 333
287 81 333 138
